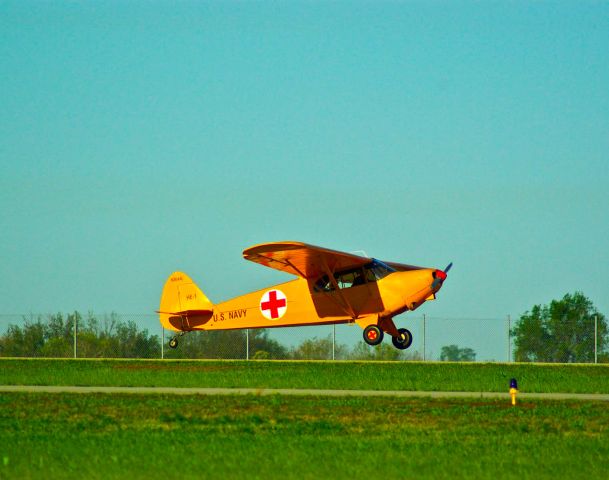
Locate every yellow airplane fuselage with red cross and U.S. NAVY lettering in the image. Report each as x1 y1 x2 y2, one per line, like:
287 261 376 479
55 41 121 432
163 260 445 330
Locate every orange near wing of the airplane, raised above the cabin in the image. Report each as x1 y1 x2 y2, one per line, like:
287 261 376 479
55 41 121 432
243 241 372 279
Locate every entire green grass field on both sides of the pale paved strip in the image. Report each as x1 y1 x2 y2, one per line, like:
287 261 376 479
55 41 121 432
0 359 609 480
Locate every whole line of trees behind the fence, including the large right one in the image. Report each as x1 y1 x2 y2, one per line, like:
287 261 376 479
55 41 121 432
0 292 609 363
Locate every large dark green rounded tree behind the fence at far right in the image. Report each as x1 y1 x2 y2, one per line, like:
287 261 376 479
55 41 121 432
511 292 607 363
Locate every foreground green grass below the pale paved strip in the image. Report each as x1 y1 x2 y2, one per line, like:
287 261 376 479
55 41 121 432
0 394 609 479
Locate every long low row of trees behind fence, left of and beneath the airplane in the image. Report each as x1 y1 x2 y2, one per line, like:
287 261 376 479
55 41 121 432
0 312 420 360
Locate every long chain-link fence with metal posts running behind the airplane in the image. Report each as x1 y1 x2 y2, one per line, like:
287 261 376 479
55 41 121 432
0 312 609 363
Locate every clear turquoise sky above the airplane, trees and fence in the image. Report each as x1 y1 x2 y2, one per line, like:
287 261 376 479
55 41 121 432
0 1 609 318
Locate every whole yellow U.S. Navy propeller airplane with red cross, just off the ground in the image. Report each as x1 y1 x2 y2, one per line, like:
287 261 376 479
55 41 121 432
157 241 452 350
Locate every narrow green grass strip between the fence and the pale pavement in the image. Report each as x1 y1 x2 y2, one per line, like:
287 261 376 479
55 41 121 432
0 359 609 393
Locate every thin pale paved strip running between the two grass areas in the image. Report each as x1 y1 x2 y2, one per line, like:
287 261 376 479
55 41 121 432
0 385 609 402
